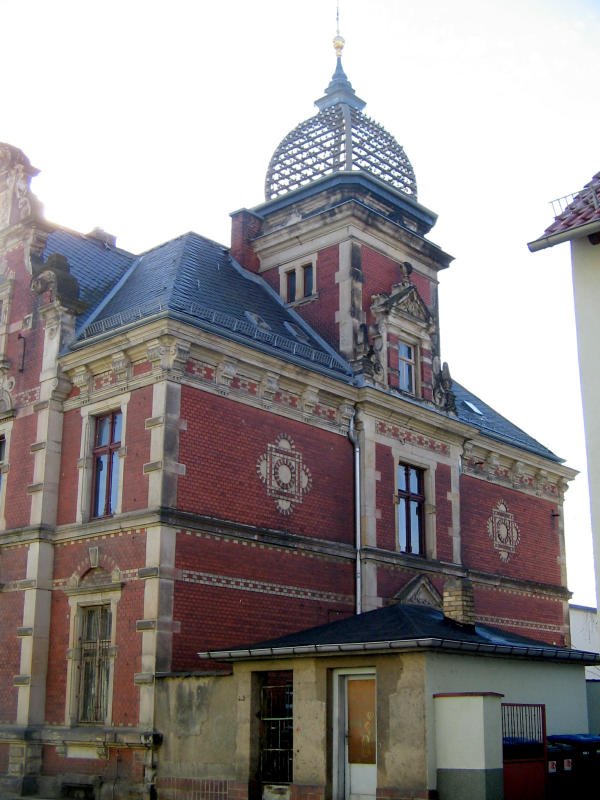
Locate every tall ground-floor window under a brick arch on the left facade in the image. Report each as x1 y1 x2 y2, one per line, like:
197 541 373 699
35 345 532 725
79 603 112 722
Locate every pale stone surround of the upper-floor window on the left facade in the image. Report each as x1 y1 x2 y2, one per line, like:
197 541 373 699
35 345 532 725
77 392 131 524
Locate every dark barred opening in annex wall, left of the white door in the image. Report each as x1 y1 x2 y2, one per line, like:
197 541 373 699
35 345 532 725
259 671 294 783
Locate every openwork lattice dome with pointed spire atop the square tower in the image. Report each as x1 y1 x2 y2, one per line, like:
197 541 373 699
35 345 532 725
265 35 417 200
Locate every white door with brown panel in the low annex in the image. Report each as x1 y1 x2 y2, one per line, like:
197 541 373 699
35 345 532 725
334 672 377 800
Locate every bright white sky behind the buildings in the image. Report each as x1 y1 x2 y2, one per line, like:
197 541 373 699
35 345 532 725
0 0 600 604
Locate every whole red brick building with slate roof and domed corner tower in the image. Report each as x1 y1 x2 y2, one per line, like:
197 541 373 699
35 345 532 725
0 45 573 797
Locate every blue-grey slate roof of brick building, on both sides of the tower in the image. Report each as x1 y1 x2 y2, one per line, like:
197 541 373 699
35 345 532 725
43 229 560 461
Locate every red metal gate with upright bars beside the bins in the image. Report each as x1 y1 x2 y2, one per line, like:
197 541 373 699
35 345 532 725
502 703 547 800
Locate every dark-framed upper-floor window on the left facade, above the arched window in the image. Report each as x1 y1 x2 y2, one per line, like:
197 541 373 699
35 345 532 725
92 411 123 517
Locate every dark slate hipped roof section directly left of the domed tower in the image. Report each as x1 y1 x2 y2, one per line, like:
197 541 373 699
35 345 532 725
73 233 351 380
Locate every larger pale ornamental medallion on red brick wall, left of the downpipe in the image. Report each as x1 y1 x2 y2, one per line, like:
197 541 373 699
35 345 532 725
256 435 312 514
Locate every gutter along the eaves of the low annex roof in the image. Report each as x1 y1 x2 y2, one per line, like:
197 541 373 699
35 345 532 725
198 637 600 665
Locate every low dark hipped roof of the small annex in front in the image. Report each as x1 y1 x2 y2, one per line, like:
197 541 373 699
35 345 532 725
198 603 600 664
